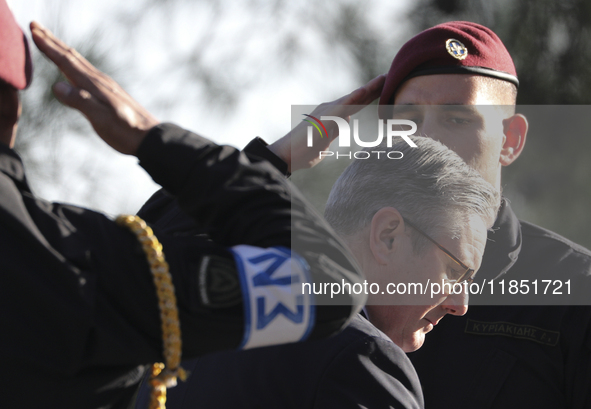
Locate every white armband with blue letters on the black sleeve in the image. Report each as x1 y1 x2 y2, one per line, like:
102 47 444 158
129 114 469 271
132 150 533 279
230 245 315 349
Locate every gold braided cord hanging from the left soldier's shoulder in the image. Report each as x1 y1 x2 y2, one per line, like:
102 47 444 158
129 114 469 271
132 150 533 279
116 215 187 409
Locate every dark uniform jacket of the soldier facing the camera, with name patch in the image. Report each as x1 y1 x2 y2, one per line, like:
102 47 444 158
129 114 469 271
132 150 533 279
409 202 591 409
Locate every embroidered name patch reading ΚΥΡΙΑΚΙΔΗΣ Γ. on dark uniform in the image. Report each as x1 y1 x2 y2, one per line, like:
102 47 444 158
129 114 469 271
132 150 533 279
464 320 560 346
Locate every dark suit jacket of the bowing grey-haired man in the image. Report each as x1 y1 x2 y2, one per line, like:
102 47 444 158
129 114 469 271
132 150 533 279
136 315 424 409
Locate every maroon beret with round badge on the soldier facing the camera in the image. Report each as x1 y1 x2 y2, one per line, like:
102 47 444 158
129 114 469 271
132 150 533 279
380 21 519 105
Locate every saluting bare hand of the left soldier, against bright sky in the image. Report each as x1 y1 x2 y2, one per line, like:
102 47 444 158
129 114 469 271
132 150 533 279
31 21 160 155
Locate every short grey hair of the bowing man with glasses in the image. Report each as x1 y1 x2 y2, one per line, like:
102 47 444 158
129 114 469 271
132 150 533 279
324 136 500 253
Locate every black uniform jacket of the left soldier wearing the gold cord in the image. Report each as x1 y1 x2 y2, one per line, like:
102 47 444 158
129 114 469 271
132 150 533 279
0 125 366 409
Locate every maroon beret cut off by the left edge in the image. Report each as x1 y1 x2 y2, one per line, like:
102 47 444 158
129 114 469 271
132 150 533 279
0 0 33 89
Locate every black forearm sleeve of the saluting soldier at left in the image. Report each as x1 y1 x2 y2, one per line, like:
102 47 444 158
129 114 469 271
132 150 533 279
138 125 365 339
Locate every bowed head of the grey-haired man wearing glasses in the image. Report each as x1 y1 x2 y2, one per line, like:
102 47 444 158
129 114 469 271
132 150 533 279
325 137 499 352
